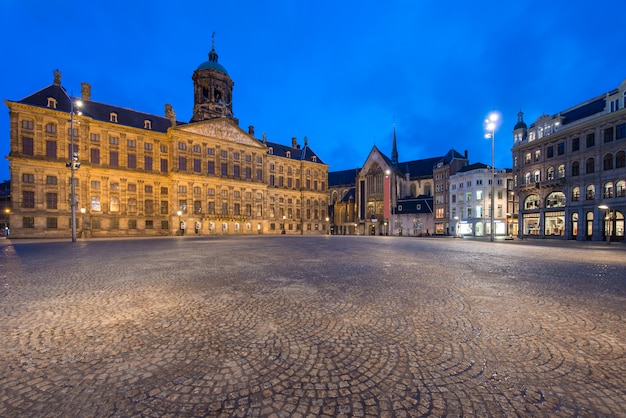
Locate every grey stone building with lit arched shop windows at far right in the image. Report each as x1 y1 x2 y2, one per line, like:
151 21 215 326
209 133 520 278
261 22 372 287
512 80 626 241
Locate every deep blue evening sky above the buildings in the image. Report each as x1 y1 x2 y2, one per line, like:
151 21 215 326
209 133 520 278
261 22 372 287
0 0 626 180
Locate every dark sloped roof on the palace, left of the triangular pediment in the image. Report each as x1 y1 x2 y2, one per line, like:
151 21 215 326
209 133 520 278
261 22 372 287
18 84 185 133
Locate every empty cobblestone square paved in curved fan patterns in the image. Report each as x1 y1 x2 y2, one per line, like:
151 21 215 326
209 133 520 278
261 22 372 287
0 236 626 417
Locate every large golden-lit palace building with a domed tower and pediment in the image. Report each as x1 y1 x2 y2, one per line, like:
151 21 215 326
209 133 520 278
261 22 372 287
5 48 328 238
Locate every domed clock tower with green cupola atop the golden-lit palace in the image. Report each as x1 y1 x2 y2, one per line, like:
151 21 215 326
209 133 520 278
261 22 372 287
191 32 235 122
